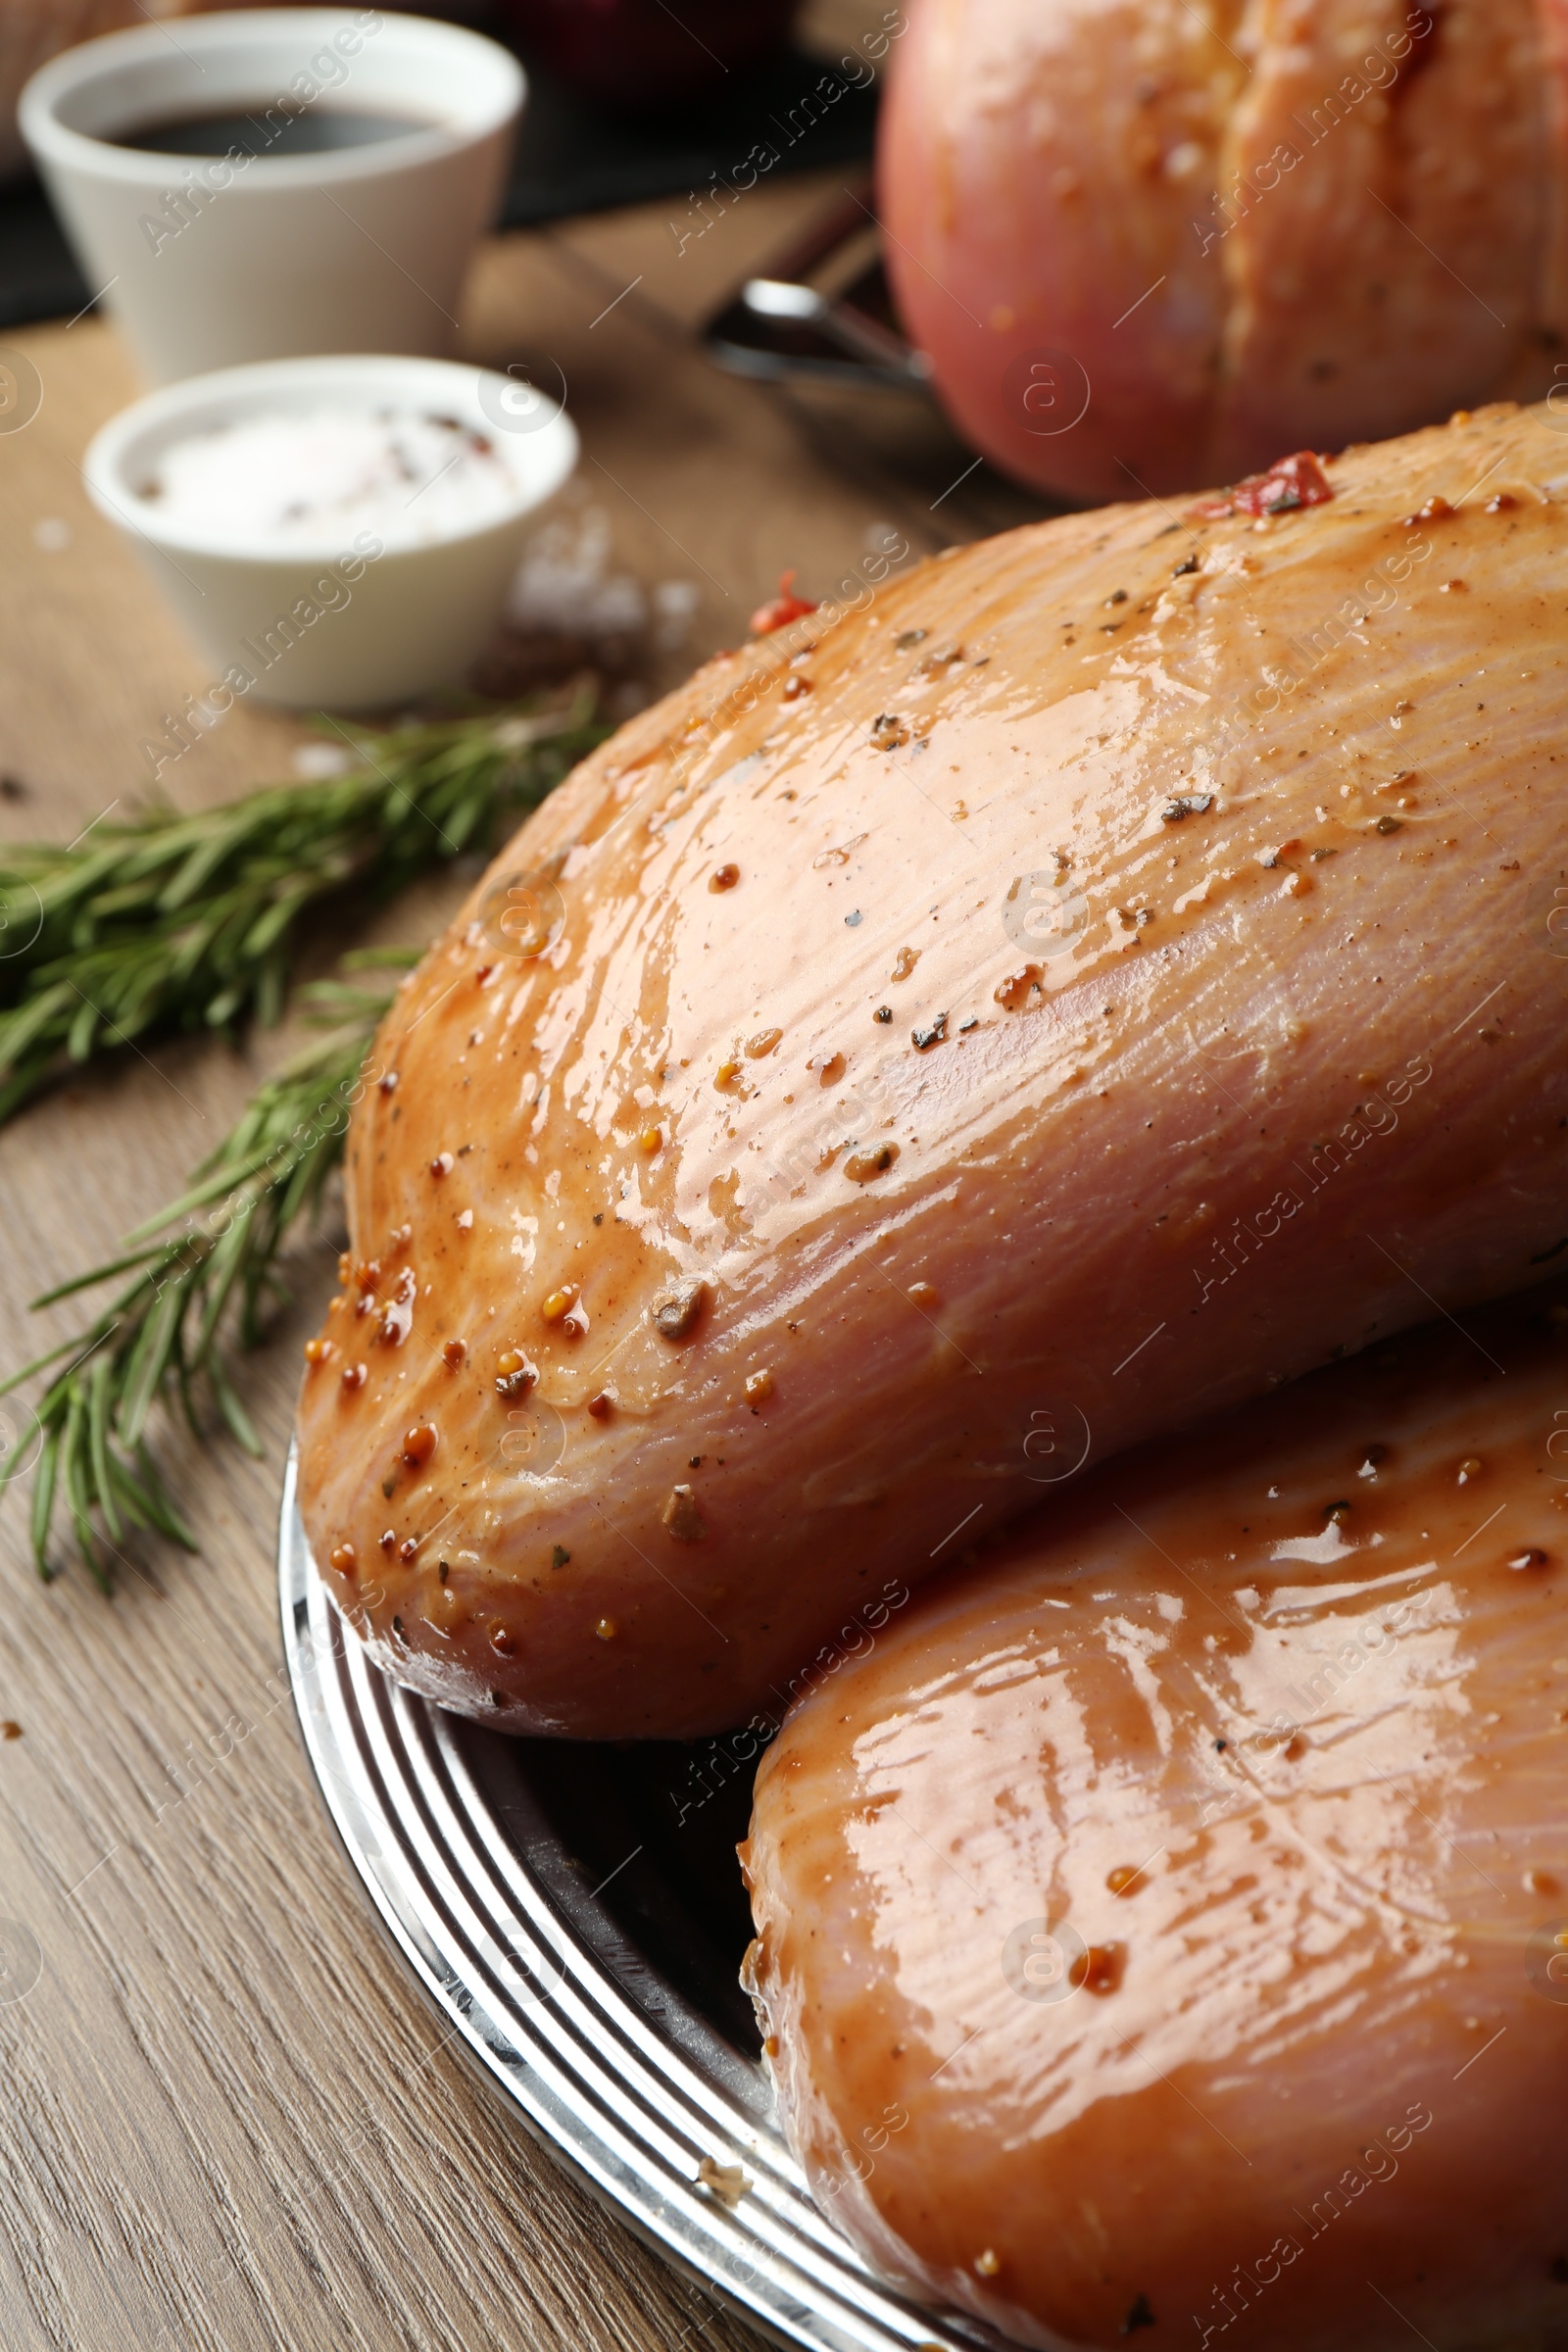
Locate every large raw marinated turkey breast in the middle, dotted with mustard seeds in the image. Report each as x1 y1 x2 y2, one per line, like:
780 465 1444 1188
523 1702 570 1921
299 395 1568 1736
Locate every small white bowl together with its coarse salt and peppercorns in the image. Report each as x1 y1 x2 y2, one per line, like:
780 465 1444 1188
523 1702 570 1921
82 358 578 712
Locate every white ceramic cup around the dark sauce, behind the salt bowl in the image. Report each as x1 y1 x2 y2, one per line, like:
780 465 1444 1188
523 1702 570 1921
19 7 524 383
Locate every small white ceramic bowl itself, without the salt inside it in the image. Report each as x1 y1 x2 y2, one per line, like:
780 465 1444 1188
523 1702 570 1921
82 358 578 712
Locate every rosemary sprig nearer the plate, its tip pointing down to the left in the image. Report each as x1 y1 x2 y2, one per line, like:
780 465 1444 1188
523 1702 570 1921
0 951 399 1592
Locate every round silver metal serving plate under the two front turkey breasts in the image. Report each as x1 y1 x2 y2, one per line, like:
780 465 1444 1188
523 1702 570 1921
277 1456 1002 2352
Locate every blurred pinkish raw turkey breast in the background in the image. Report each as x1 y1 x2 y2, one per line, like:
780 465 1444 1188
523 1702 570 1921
877 0 1568 499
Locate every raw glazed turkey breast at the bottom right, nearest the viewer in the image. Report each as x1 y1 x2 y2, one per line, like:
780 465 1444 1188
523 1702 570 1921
743 1289 1568 2352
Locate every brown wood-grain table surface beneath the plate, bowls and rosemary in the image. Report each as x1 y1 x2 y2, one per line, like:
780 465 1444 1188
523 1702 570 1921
0 82 1053 2352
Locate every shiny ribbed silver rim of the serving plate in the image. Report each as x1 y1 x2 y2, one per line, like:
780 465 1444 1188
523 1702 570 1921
277 1448 1004 2352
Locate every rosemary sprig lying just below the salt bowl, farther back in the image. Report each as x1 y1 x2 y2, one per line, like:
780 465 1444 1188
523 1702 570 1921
0 692 604 1119
